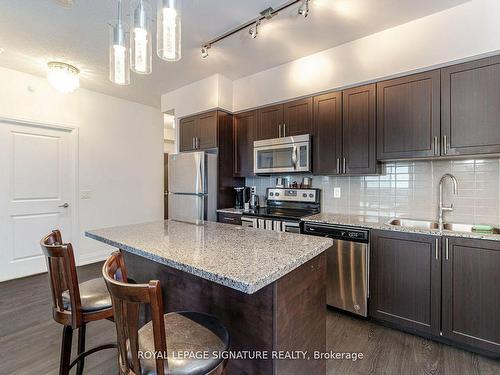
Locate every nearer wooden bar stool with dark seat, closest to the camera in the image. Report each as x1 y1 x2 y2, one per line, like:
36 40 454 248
102 252 229 375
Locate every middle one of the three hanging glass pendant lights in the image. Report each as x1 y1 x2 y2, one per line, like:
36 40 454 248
130 0 153 74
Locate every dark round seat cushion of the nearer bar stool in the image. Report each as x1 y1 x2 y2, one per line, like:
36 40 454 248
129 311 229 375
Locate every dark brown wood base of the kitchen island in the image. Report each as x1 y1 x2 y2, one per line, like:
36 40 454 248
123 251 326 375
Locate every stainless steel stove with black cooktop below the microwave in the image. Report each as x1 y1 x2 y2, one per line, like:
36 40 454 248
241 188 321 233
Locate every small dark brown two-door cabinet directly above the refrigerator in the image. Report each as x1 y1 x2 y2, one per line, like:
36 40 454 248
179 111 219 152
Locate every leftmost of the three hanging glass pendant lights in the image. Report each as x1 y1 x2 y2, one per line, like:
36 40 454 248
109 0 130 85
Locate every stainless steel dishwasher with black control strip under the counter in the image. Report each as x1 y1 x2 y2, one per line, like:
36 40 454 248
303 222 370 316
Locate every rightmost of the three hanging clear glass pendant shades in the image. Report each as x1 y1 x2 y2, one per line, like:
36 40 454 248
157 0 182 61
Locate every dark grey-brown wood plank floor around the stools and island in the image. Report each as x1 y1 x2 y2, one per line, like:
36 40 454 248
0 263 500 375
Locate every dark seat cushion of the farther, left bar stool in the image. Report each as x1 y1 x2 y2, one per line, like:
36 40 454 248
62 278 111 312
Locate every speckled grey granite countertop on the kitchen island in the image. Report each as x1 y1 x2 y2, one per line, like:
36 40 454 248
85 220 333 294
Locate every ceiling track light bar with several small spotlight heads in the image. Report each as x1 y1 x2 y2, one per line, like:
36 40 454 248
201 0 309 58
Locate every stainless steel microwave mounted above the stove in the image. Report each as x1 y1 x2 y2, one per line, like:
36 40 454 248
253 134 311 174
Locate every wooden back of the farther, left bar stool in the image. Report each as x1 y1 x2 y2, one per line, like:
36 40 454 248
40 230 83 329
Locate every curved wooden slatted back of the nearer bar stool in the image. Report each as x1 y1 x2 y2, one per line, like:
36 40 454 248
102 252 168 375
